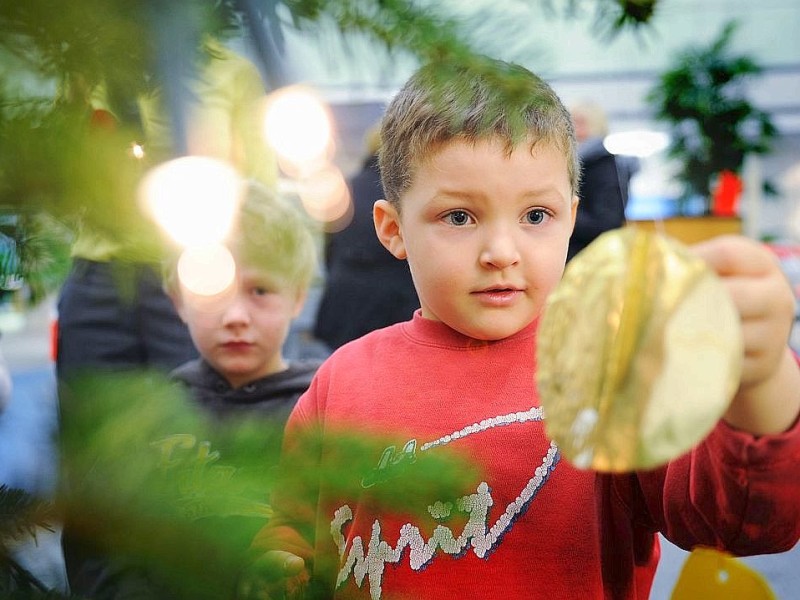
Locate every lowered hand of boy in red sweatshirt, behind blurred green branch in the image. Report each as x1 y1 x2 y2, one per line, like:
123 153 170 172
236 550 307 600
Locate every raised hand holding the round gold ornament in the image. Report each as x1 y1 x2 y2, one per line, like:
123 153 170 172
692 236 800 434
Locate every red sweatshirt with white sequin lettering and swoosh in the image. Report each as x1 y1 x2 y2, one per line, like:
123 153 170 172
254 313 800 600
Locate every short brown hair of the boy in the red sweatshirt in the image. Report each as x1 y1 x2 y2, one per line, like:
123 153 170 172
379 58 580 207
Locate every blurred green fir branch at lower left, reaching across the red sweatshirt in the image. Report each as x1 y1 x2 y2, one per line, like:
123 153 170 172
58 373 475 599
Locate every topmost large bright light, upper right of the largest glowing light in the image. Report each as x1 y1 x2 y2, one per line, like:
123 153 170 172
264 85 332 175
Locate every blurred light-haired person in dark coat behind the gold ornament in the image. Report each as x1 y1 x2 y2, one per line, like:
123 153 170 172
567 103 636 261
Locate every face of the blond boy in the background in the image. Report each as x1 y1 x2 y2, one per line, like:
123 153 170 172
174 266 305 388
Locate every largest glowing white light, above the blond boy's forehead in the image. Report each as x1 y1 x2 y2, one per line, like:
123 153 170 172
140 156 242 247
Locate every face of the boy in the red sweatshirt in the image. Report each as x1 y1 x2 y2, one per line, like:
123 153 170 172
374 140 577 340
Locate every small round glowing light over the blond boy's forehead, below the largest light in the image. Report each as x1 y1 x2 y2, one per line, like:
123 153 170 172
178 244 236 296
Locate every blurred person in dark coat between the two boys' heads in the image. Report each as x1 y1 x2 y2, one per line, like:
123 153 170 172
314 127 419 349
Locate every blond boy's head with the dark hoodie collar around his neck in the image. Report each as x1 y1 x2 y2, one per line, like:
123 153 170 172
167 181 319 424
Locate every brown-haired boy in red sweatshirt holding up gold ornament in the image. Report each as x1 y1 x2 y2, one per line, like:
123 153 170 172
241 58 800 599
